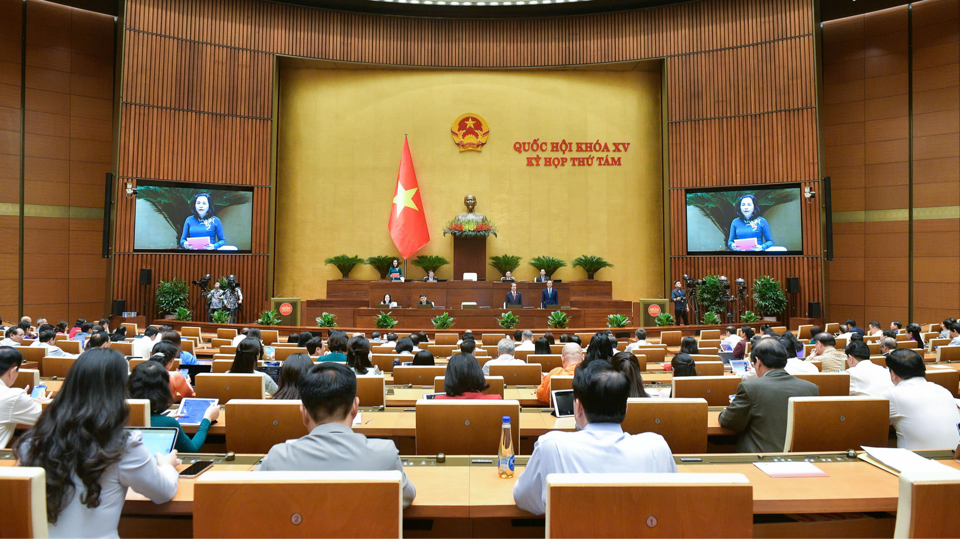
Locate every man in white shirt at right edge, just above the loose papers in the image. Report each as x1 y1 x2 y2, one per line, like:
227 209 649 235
878 349 960 451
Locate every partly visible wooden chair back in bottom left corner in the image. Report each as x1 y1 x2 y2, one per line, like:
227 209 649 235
0 467 49 538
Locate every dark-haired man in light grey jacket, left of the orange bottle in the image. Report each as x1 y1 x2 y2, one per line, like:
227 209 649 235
259 363 417 508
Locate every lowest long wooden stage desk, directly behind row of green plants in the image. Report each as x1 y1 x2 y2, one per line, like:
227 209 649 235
354 308 583 330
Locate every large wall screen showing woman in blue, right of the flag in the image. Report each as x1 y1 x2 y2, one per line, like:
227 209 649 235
687 184 803 255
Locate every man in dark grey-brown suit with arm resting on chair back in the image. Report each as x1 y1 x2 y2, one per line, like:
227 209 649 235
720 339 820 454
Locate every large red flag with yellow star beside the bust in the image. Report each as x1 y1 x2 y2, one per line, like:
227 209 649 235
387 137 430 260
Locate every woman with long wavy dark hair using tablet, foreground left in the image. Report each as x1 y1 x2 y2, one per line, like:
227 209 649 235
15 349 178 538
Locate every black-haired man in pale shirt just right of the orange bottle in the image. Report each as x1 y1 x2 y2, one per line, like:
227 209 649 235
513 354 677 515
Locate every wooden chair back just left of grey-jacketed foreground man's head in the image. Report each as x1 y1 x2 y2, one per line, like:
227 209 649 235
224 398 307 454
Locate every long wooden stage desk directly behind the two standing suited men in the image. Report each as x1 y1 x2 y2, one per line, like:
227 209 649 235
369 281 577 310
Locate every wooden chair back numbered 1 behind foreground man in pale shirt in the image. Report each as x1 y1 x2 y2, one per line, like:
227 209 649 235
546 473 753 540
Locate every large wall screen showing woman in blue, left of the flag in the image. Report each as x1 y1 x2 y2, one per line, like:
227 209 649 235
133 182 253 253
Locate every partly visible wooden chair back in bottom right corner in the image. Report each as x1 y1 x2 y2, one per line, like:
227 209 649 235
893 470 960 540
